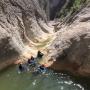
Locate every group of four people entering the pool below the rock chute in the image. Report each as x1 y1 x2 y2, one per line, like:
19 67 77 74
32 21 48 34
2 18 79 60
18 51 46 73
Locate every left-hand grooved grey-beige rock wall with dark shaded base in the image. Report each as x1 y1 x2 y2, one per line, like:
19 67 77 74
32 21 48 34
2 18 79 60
0 0 52 69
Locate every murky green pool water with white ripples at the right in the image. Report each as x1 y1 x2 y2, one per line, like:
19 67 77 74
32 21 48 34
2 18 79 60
0 66 84 90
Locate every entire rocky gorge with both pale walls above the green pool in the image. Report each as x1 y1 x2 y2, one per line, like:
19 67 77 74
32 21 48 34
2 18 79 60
0 0 90 76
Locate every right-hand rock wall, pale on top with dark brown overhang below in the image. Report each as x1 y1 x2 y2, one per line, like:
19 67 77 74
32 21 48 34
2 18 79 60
48 6 90 76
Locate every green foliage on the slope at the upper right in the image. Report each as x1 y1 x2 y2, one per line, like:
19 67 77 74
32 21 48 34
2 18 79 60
56 0 88 18
